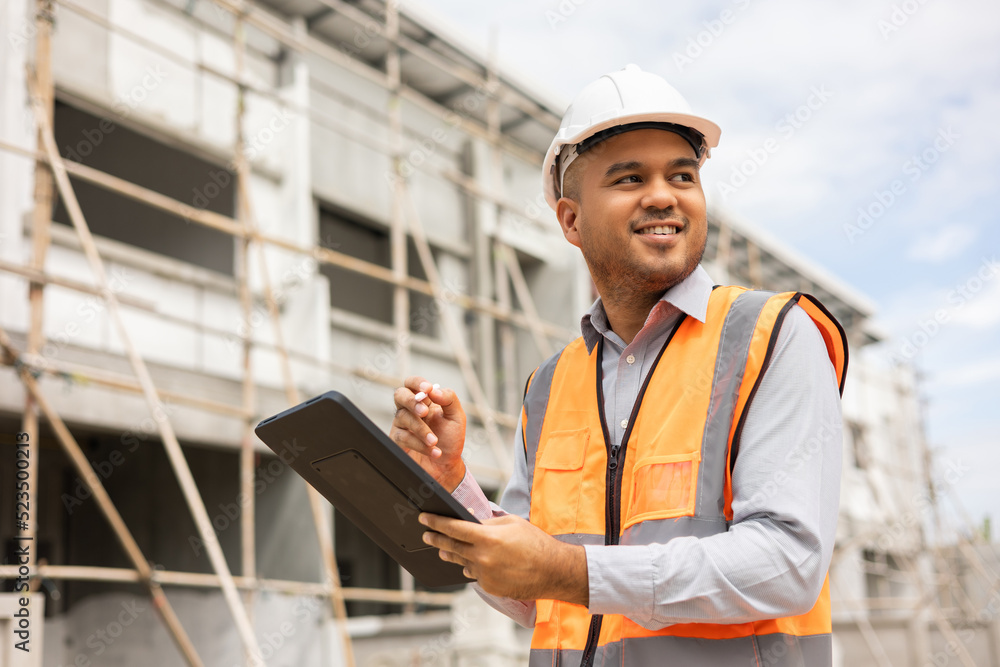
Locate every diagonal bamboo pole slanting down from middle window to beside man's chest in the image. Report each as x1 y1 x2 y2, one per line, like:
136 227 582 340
404 188 511 476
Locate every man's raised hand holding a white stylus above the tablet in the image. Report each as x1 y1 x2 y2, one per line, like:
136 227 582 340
389 377 465 493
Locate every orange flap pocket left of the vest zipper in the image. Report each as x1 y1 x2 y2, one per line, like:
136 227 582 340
531 428 590 535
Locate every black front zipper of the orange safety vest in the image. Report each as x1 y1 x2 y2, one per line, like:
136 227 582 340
580 326 687 667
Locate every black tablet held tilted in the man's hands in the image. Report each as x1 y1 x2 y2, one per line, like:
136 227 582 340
254 391 478 588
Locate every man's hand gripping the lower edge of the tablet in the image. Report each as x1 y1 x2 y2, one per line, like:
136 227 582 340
420 513 590 606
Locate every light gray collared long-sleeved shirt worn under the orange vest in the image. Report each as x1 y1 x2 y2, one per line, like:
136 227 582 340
453 266 843 629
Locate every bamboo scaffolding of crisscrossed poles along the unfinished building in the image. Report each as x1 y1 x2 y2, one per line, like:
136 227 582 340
0 0 572 666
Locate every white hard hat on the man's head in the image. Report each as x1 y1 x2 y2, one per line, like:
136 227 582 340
542 65 722 210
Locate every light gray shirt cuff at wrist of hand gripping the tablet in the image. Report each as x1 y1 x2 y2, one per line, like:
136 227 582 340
583 545 656 625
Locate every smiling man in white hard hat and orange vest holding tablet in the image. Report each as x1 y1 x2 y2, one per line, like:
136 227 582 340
391 65 847 666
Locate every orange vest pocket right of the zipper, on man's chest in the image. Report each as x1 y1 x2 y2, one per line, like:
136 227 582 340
622 452 701 530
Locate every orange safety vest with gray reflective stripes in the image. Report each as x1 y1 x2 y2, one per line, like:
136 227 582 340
521 287 847 667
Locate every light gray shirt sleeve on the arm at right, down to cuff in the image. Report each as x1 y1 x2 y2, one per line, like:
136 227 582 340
585 306 843 630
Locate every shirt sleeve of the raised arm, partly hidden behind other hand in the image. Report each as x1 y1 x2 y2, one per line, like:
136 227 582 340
451 420 535 628
